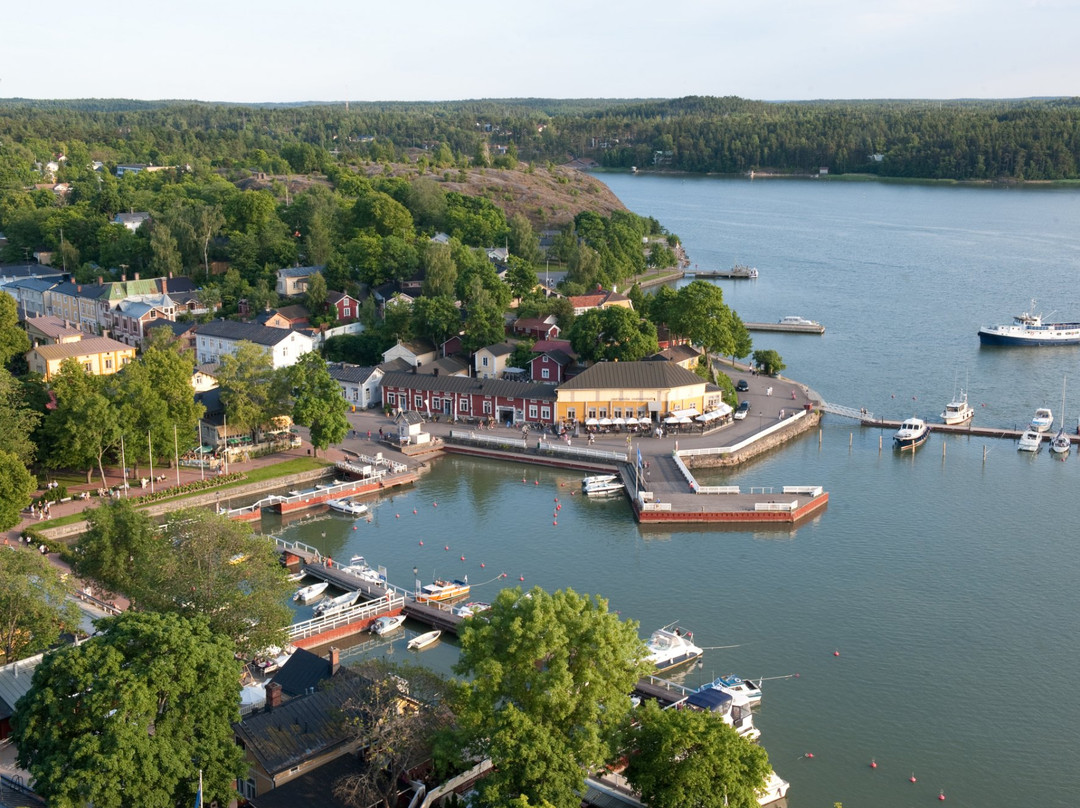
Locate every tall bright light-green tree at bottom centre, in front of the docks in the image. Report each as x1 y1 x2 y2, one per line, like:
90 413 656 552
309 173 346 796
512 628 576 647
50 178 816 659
455 588 648 808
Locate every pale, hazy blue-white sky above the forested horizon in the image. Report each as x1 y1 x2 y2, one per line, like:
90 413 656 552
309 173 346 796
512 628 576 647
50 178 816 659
8 0 1080 103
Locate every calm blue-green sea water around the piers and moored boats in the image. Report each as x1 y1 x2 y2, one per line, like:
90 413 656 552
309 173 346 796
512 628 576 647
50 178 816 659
274 174 1080 808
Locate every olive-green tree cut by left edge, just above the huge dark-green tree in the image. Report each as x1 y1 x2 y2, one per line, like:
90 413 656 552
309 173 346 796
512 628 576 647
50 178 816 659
0 542 79 663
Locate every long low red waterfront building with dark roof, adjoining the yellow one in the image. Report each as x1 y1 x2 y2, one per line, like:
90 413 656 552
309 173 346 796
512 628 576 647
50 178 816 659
382 372 556 423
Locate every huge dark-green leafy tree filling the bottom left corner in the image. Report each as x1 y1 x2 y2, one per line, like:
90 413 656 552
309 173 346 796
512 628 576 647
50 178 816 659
12 611 244 808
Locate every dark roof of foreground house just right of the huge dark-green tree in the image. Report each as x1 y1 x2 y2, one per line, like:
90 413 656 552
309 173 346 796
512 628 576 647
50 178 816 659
232 669 370 775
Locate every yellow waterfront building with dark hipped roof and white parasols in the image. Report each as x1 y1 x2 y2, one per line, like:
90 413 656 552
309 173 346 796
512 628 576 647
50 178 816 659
555 362 721 422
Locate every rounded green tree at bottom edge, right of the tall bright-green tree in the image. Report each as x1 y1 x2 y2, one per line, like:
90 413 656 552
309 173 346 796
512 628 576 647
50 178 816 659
625 701 770 808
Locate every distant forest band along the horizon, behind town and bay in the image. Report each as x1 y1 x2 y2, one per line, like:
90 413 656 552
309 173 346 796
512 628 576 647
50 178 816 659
0 97 1080 180
